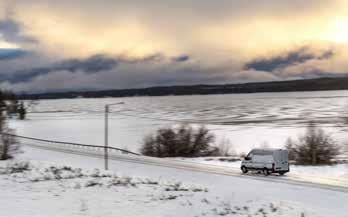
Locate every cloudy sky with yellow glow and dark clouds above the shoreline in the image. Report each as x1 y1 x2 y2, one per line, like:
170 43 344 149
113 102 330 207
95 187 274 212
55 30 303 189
0 0 348 92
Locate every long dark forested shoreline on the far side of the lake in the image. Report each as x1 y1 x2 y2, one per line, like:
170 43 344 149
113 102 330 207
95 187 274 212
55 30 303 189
19 77 348 100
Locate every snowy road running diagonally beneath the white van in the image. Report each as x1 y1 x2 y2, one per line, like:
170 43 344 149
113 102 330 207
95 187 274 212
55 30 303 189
23 144 348 192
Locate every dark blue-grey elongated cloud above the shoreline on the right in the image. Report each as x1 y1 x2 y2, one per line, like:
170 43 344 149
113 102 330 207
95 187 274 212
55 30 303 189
244 47 334 72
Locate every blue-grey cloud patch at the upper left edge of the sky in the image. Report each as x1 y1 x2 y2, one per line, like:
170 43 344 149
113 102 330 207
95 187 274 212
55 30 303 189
0 19 37 43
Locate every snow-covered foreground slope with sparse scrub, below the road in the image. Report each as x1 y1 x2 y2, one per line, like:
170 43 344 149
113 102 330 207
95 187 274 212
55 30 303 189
0 146 348 217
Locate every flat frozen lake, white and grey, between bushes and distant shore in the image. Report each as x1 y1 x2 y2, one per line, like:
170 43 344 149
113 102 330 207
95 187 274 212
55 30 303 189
10 91 348 152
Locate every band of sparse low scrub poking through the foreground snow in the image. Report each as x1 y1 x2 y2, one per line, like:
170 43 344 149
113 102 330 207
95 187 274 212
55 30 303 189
0 161 207 195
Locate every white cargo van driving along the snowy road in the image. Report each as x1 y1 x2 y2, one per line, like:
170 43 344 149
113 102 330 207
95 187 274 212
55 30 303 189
240 149 290 175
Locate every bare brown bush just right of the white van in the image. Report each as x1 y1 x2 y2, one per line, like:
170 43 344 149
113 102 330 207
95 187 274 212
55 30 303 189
286 122 339 165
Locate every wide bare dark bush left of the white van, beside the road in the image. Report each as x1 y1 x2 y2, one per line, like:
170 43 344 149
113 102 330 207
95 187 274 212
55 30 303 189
140 125 220 157
